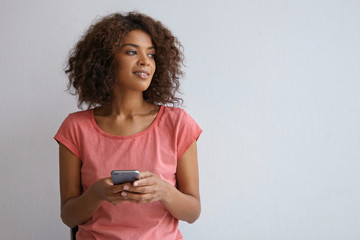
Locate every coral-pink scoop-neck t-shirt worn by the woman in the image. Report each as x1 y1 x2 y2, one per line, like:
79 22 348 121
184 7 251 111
55 106 202 240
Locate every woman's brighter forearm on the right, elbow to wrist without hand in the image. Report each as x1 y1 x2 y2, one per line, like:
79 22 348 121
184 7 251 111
160 184 201 223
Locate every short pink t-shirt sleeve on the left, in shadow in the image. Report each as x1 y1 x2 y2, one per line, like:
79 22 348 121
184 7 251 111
54 114 81 159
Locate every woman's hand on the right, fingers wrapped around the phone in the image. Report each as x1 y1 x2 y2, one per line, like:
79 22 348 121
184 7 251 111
121 172 173 203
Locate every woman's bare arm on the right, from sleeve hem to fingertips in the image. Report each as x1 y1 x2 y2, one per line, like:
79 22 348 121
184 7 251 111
122 141 201 223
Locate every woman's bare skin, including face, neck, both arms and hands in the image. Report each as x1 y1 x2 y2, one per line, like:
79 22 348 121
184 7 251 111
59 30 201 227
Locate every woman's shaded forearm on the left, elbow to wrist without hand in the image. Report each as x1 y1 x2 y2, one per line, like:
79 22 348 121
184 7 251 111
61 186 103 228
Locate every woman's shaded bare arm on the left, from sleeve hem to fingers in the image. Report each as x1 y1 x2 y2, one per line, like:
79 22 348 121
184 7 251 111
59 143 123 228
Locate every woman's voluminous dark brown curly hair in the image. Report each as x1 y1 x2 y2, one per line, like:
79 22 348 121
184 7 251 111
65 12 183 108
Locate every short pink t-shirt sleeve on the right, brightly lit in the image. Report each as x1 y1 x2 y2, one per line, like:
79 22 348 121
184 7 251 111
177 110 202 160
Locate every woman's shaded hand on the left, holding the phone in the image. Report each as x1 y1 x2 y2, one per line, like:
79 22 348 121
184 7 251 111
93 177 129 205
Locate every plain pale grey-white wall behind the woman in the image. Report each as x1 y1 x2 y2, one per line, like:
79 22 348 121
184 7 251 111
0 0 360 240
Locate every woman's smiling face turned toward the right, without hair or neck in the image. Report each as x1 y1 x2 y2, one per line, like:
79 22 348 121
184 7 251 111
114 30 156 92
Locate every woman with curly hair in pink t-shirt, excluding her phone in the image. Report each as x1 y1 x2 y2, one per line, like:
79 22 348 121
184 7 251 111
55 12 202 239
